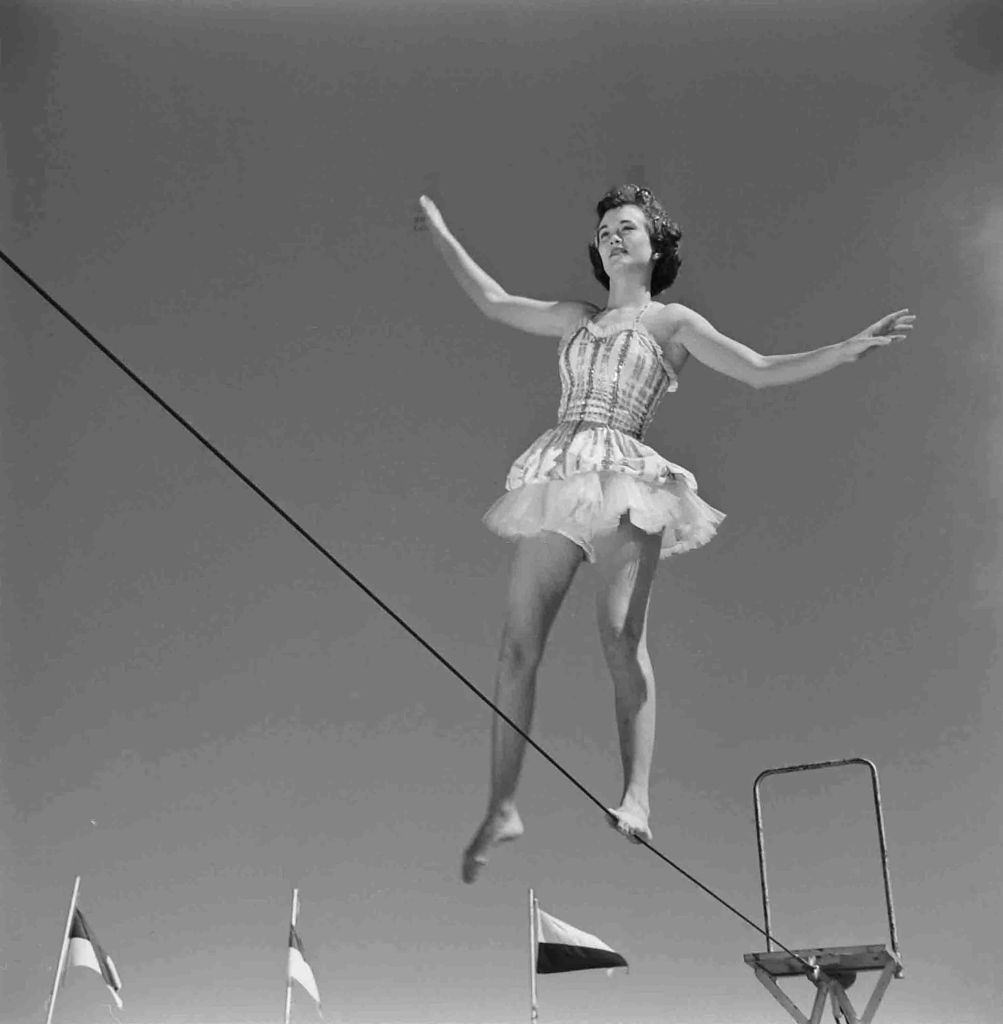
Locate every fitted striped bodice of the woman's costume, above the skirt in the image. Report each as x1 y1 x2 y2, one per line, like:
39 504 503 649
557 307 678 440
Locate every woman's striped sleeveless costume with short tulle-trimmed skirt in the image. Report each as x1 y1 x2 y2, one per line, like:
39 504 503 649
485 303 724 562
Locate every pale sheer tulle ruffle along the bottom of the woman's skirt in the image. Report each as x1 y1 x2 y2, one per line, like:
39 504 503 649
484 470 724 558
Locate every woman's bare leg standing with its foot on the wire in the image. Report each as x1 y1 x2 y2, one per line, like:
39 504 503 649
596 520 662 840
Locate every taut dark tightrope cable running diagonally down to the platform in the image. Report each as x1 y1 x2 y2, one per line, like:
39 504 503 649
0 243 816 974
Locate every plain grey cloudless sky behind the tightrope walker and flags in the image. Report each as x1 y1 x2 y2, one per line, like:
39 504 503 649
0 0 1003 1024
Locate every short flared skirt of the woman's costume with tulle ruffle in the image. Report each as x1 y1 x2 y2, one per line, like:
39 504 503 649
485 423 724 561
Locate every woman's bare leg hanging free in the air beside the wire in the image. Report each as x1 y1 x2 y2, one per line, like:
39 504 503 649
463 532 582 882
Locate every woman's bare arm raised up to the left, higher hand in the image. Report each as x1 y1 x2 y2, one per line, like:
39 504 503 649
418 196 589 337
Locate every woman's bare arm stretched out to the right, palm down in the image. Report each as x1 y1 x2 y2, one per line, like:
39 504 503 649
667 305 916 388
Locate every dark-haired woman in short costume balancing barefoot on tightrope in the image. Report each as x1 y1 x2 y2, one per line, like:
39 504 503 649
419 185 915 882
